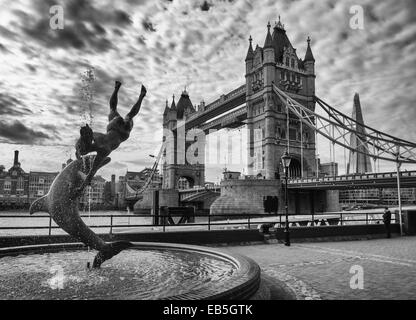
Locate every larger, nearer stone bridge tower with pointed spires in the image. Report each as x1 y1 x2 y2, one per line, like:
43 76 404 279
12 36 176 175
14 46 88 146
245 17 316 179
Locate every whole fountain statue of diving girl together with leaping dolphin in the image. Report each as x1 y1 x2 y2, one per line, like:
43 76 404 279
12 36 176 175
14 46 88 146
29 81 146 268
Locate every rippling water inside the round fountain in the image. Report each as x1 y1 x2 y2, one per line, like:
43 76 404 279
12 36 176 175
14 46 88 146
0 249 237 300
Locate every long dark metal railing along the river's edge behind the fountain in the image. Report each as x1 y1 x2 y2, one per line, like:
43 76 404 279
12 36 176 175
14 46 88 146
0 212 396 237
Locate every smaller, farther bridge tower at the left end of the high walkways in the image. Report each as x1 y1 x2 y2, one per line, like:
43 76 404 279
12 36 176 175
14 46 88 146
162 89 205 189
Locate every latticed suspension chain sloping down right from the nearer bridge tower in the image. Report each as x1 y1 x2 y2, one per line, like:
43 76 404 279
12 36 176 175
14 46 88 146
273 85 416 163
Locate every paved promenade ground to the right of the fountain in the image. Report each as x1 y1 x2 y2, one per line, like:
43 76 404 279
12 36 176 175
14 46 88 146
223 237 416 300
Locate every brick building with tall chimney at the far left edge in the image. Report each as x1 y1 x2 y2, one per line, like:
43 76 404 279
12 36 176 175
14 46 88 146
0 150 29 208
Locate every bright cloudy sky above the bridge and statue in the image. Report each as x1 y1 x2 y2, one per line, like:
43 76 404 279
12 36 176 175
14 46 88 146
0 0 416 180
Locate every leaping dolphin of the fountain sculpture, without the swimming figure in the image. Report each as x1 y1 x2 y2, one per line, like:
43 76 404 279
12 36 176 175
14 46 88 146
29 157 133 268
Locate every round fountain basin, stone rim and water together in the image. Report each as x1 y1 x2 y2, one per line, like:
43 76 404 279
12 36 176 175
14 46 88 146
0 242 260 300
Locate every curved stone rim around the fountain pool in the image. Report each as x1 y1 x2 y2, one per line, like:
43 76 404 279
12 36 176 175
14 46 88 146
0 242 261 300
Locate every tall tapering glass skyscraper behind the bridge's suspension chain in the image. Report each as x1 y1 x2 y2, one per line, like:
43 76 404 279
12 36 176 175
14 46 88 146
347 93 372 174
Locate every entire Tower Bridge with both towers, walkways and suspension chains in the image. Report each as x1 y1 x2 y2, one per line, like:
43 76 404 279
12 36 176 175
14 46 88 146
129 19 416 215
